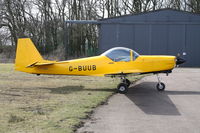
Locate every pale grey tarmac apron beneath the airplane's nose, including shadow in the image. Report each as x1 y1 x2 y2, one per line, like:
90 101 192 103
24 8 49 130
77 68 200 133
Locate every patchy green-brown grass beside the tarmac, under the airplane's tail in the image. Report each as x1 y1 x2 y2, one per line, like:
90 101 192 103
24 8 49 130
0 64 142 133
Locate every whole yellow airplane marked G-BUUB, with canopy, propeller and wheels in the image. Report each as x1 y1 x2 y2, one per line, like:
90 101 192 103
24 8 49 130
15 38 185 93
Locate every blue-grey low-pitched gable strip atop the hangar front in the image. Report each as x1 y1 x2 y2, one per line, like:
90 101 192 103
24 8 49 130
99 8 200 23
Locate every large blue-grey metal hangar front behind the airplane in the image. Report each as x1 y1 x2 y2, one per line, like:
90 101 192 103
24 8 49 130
99 9 200 67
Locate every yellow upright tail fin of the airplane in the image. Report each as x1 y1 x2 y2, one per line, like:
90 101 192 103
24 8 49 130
15 38 43 71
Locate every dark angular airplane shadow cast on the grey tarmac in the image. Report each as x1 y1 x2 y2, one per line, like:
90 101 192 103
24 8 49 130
126 82 181 115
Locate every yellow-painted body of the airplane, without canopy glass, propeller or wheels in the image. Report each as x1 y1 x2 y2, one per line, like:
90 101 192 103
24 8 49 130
15 38 176 76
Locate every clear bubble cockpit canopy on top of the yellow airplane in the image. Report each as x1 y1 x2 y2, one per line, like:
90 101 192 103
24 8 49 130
101 47 139 62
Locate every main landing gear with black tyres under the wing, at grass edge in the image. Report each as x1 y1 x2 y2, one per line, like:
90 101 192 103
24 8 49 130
117 76 131 94
